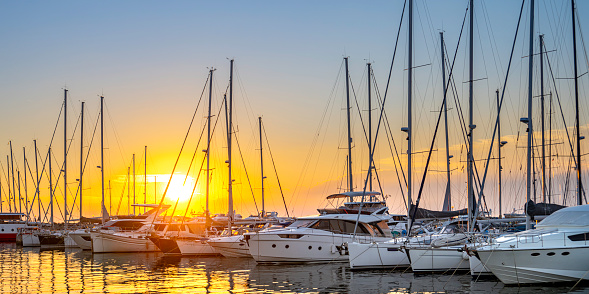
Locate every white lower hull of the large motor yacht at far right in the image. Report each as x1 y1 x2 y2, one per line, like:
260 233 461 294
477 246 589 285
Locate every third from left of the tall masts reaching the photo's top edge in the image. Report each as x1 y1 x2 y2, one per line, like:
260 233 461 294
526 0 534 230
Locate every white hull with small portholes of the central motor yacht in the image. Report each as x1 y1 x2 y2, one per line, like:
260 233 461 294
248 231 376 263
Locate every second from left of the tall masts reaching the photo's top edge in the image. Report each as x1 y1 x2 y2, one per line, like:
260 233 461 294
467 0 476 228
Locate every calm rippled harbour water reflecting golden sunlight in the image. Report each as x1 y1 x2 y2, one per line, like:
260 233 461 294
0 243 589 294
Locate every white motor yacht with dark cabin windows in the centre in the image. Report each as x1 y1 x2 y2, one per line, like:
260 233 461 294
244 211 392 263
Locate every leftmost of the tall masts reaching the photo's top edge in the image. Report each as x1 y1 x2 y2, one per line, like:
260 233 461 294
407 0 413 223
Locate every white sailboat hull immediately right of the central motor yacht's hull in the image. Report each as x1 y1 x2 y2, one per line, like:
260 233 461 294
348 242 410 269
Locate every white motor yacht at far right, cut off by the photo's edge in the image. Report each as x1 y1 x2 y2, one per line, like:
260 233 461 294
475 205 589 285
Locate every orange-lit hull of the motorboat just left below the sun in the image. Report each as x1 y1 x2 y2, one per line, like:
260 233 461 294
90 232 160 253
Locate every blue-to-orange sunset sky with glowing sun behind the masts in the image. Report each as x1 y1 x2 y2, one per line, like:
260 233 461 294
0 0 589 217
